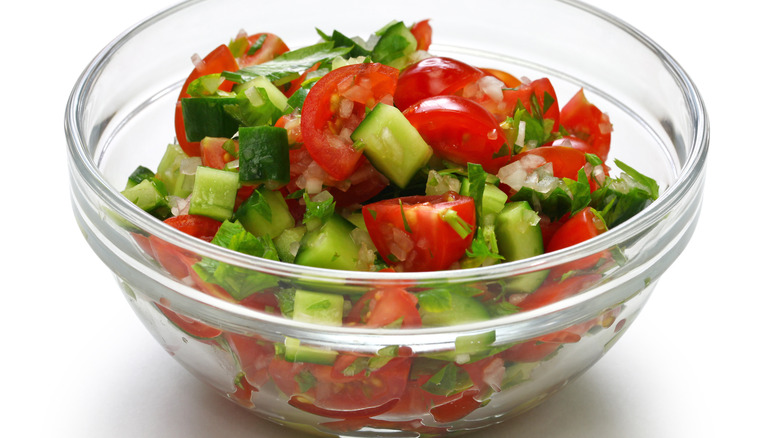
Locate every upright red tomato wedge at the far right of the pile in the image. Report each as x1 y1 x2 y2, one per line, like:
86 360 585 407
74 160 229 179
561 88 612 161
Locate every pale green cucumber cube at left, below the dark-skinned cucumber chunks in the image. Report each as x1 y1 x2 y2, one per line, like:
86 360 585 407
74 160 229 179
190 166 239 221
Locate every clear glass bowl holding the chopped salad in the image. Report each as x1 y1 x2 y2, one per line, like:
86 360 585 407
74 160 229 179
65 0 709 436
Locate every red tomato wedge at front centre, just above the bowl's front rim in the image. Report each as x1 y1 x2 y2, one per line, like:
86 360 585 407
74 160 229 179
363 192 476 271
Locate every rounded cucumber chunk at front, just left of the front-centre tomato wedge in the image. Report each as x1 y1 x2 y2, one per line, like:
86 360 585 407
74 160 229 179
295 214 360 271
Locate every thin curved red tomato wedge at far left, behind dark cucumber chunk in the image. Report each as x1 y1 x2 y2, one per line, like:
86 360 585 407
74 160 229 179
174 44 238 157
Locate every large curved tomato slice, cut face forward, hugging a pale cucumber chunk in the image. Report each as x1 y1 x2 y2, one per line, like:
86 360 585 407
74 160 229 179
301 63 398 181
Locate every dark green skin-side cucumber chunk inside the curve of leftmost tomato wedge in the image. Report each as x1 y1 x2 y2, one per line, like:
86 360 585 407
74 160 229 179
181 97 239 141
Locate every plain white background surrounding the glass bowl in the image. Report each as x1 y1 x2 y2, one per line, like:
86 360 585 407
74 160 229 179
0 0 780 438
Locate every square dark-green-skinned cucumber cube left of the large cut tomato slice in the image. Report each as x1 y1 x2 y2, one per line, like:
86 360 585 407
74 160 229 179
238 126 290 185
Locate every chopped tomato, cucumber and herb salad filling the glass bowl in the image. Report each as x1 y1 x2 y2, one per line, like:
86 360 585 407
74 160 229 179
122 20 659 433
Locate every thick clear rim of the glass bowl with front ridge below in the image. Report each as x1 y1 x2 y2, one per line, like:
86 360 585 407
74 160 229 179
65 0 709 336
